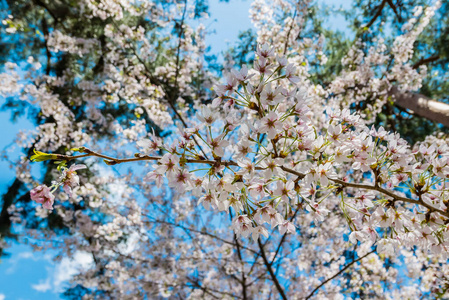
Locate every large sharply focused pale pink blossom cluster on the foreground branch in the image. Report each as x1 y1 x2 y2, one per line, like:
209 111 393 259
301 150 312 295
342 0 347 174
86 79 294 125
131 45 449 252
